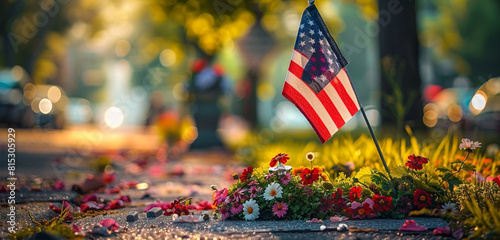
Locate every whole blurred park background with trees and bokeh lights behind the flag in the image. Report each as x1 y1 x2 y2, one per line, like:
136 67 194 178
0 0 500 171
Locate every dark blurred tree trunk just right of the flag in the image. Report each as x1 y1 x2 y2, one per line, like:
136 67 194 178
378 0 423 131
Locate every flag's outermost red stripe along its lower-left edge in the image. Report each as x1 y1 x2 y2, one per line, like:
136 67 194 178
282 82 331 143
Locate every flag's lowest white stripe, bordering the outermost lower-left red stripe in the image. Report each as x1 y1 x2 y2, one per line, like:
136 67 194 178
286 71 338 136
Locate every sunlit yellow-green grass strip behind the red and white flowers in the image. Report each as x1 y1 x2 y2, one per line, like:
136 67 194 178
240 129 500 179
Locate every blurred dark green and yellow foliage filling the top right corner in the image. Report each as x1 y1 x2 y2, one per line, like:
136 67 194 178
419 0 500 81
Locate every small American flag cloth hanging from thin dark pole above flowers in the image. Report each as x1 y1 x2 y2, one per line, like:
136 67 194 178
282 4 360 143
